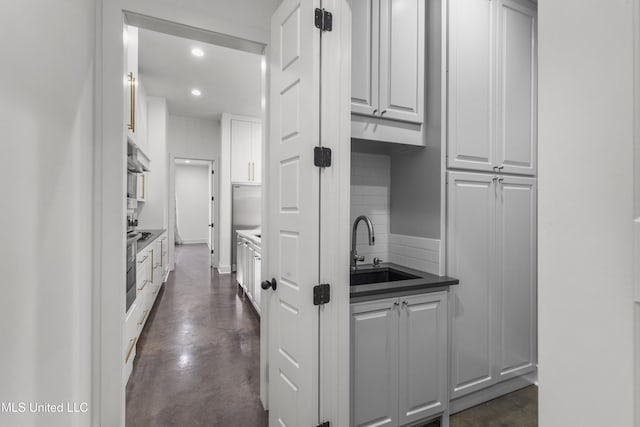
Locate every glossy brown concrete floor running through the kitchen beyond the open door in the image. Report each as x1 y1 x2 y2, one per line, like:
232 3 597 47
126 245 267 427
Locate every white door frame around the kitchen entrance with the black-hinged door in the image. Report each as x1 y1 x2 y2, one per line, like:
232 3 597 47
91 0 355 426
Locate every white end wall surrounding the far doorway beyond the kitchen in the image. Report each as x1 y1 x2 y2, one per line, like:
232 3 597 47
167 115 220 270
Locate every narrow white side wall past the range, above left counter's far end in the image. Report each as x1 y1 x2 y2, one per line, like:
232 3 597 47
138 96 169 230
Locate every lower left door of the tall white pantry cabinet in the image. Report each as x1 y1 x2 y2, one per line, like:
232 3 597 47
447 172 497 398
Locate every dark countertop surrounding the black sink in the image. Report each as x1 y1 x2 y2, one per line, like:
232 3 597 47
350 262 460 302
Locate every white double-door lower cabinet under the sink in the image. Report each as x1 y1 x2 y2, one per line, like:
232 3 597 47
351 292 448 426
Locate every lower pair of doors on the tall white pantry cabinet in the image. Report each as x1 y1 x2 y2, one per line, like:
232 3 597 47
447 172 536 399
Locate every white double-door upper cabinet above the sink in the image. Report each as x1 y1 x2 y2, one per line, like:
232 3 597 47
351 0 425 124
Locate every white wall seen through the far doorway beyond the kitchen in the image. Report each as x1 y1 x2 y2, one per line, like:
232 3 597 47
175 164 209 243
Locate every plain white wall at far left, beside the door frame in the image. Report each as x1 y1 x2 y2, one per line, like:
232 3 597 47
0 0 95 427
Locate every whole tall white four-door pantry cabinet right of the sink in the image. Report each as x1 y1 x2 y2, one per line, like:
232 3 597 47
447 0 537 412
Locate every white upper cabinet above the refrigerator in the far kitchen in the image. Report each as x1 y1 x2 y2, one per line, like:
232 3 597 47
230 116 262 182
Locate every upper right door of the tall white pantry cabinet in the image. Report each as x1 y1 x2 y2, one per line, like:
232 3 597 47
496 0 537 175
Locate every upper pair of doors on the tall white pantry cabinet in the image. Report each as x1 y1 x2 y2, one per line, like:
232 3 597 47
448 0 537 175
